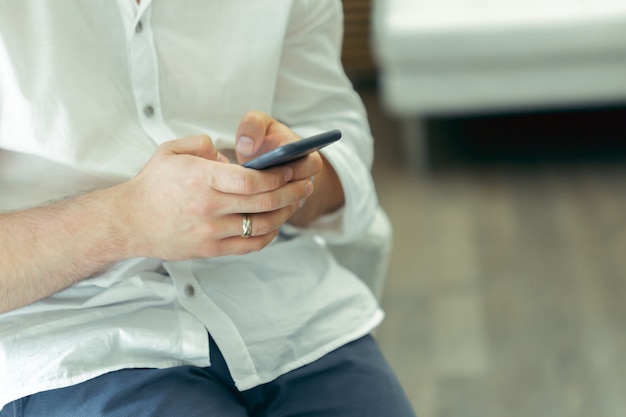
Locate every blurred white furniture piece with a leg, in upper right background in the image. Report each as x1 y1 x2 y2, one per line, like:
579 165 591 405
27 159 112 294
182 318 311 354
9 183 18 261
373 0 626 169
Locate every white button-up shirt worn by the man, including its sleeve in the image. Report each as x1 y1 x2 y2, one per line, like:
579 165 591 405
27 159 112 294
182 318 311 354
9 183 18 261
0 0 382 407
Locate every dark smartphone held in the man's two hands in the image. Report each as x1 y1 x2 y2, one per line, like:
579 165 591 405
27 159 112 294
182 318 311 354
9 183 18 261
243 129 341 169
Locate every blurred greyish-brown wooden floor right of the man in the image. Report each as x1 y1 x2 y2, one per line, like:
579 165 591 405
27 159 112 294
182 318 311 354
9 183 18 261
359 88 626 417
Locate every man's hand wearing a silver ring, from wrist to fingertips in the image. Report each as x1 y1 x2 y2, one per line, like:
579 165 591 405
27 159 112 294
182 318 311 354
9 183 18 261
115 135 312 260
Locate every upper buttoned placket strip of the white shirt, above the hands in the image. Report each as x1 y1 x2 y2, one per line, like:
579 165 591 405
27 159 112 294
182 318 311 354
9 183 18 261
128 2 174 144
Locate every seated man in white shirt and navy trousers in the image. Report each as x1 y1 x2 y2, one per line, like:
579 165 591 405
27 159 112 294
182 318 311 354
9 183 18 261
0 0 420 416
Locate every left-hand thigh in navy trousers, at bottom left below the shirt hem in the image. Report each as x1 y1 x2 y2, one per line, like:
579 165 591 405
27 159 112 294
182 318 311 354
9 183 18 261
0 366 248 417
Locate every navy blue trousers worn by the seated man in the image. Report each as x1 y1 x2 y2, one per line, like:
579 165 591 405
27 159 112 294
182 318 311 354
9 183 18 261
0 336 415 417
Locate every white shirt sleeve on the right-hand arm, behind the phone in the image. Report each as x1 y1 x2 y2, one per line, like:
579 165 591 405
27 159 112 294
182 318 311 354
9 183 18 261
273 0 378 243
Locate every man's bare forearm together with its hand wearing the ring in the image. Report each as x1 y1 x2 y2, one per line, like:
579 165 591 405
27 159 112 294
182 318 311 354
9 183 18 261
0 136 313 313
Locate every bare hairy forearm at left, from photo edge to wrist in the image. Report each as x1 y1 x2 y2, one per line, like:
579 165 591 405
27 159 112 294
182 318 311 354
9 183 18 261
0 185 124 312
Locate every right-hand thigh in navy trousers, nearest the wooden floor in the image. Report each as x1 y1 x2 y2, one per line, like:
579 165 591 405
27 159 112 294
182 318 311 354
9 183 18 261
244 336 415 417
